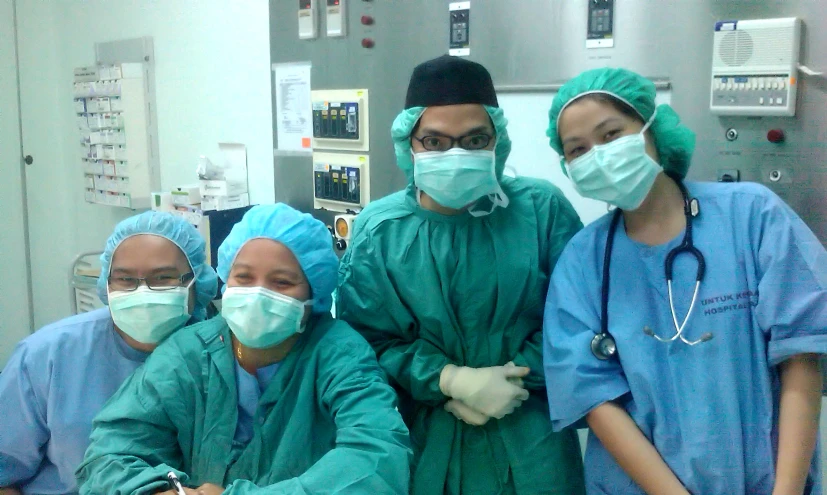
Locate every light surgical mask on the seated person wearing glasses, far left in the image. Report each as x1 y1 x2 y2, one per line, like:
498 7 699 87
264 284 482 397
109 286 190 344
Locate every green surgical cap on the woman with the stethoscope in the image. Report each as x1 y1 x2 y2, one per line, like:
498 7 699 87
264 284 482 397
546 68 695 178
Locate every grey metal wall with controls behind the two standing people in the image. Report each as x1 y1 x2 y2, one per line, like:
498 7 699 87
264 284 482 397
271 0 827 246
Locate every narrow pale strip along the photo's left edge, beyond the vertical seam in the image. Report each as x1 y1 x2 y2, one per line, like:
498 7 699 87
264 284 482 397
0 1 32 368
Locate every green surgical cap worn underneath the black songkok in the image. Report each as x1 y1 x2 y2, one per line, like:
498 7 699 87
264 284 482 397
391 105 511 184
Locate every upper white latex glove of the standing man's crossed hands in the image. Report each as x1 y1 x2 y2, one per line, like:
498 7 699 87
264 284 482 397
439 363 531 419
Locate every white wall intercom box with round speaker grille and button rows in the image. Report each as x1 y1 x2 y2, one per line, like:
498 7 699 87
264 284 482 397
709 18 801 117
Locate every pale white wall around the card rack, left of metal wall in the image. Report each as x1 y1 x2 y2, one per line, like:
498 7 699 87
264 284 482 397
18 0 274 334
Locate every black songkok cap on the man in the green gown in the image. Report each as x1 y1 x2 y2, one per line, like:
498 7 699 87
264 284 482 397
405 55 500 109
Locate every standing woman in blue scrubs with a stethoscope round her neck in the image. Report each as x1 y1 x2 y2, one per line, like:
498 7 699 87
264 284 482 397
544 69 827 495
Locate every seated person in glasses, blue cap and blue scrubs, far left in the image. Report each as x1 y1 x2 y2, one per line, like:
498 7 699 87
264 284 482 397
0 211 218 495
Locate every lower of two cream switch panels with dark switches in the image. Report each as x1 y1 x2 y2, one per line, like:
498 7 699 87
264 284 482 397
313 153 370 212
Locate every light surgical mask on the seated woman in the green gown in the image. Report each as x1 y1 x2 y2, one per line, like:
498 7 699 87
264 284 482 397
221 287 313 349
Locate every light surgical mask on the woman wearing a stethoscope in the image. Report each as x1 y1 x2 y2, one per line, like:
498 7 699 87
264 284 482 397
566 115 663 211
